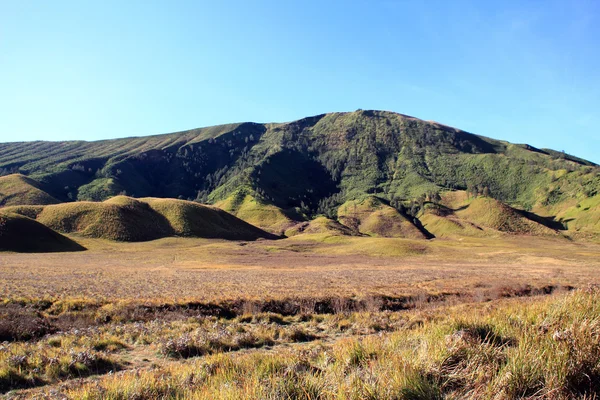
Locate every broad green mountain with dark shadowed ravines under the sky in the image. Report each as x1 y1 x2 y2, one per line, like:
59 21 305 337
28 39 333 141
0 110 600 237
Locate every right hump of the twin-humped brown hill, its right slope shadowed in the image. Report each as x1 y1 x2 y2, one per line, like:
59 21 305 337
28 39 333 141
140 198 276 240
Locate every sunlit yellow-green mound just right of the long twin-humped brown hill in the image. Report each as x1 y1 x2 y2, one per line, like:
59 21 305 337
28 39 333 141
215 190 297 234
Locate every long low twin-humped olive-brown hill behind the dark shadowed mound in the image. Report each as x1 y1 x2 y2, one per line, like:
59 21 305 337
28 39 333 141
4 196 275 242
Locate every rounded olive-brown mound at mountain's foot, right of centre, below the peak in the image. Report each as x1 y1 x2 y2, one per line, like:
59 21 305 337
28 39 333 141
338 196 428 239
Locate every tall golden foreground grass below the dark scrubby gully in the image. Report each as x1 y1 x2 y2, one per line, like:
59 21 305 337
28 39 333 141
0 287 600 400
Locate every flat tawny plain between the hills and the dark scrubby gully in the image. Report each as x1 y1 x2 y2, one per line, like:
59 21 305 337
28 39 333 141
0 235 600 302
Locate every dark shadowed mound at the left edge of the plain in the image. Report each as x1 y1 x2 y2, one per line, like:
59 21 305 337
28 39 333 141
0 211 85 253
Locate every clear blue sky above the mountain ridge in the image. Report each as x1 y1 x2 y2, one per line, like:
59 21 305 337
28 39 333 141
0 0 600 163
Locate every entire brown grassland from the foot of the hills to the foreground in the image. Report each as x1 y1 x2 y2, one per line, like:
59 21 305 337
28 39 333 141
0 234 600 399
